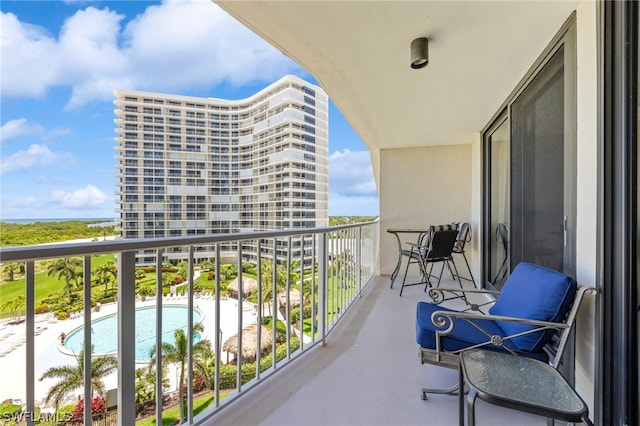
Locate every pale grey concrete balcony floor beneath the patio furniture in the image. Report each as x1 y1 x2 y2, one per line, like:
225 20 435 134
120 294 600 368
210 266 547 426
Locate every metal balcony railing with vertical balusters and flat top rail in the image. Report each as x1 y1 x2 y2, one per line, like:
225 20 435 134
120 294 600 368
0 221 379 425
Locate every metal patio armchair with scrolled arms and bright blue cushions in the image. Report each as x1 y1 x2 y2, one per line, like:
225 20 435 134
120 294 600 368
415 262 596 399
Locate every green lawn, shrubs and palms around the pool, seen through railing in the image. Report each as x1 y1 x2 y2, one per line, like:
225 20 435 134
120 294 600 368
0 251 356 424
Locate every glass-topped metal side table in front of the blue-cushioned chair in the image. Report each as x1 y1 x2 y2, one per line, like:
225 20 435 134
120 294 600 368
458 349 593 426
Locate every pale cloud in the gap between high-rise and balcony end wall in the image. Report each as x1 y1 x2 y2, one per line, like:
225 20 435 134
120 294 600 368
329 149 378 197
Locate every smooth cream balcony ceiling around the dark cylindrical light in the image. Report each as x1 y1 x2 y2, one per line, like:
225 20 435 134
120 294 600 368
214 0 576 151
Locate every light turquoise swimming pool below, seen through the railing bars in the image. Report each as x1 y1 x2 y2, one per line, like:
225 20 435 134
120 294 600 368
64 305 202 362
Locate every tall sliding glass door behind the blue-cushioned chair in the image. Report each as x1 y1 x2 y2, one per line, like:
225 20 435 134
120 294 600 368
483 16 576 290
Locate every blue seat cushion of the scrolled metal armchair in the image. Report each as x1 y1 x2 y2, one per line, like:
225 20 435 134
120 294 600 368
416 302 549 362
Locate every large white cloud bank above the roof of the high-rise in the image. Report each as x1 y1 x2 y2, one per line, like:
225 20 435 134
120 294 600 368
0 0 298 109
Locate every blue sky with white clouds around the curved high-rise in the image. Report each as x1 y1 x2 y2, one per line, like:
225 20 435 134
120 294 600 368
0 0 378 220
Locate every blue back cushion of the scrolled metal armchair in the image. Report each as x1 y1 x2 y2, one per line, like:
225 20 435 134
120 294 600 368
489 262 577 352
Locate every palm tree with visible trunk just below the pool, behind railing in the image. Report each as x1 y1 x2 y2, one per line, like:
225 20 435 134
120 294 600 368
149 324 211 423
